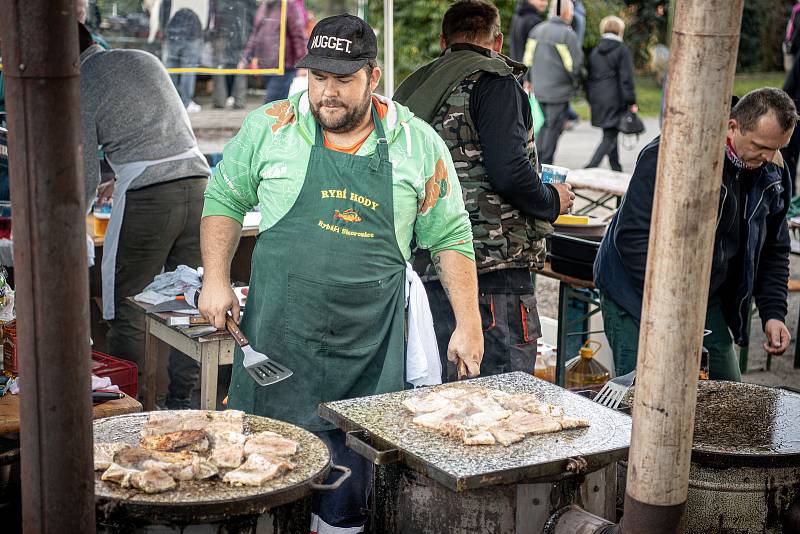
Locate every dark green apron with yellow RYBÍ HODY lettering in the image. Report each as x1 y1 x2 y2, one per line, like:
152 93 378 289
229 106 405 431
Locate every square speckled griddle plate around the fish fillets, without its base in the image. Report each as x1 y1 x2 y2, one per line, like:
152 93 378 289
319 372 631 491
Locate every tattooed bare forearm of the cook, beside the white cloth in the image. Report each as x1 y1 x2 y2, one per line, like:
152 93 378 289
433 250 481 328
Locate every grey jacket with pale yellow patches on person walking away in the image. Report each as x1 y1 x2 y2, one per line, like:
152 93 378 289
525 17 583 104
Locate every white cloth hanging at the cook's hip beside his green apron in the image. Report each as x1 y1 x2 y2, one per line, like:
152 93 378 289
406 262 442 387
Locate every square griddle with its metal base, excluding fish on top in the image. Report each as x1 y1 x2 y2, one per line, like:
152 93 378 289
320 372 631 534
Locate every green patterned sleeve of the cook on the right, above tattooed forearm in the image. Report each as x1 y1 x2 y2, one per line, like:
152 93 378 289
414 135 475 261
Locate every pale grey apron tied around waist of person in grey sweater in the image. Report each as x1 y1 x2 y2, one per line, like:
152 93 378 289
101 145 204 320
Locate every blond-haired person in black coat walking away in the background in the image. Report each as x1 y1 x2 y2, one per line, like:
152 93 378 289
586 16 636 171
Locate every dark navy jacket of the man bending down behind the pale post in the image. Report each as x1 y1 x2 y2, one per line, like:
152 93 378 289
594 138 791 345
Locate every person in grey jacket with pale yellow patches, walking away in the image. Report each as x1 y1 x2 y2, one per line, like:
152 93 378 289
523 0 583 163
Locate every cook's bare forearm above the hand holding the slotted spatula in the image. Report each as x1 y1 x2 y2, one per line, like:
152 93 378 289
200 215 242 284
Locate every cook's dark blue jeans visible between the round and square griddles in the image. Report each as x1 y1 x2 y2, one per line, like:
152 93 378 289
311 429 373 528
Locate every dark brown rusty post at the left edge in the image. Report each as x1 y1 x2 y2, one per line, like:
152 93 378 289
0 0 96 534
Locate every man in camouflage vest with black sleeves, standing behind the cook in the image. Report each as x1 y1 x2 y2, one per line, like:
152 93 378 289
394 0 574 380
